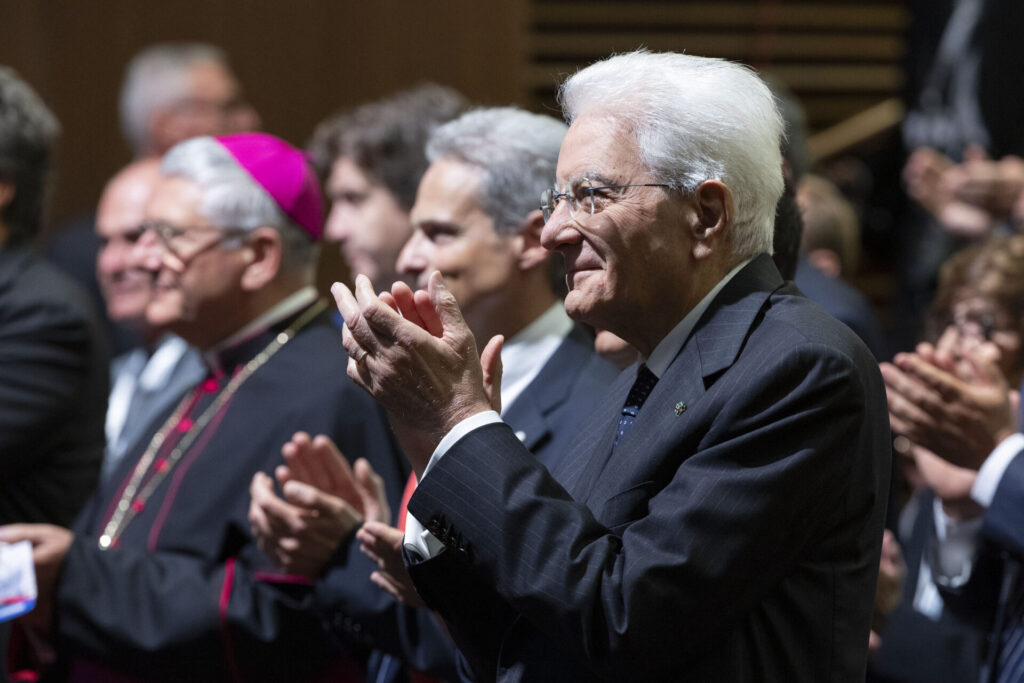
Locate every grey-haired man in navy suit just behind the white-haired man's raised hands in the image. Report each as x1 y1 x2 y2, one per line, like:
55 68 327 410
249 108 617 674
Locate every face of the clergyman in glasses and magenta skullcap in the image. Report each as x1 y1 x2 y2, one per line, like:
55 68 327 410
132 177 251 348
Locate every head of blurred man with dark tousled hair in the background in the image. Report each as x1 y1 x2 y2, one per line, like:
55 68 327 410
309 83 468 291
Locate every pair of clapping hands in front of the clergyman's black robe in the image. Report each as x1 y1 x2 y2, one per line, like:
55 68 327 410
249 432 374 579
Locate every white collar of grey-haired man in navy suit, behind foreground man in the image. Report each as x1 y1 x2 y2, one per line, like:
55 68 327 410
502 302 572 410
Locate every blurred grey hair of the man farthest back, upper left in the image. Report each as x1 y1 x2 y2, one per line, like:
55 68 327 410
119 43 227 156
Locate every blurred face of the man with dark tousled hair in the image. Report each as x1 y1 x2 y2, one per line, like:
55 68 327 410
324 157 413 290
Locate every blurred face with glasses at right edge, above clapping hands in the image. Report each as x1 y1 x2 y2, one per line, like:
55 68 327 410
936 297 1024 386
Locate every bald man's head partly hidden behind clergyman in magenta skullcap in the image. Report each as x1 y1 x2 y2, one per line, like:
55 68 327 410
96 159 160 332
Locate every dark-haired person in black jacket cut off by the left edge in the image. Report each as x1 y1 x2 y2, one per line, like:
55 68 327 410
0 67 110 679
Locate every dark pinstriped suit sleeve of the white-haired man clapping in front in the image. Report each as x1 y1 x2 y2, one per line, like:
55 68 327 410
410 344 888 680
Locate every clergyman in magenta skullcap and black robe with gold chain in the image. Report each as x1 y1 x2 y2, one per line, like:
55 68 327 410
0 133 404 681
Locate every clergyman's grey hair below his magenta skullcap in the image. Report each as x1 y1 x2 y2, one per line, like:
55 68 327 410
160 136 316 267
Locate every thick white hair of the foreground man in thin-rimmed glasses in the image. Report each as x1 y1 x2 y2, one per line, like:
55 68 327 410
558 50 784 261
